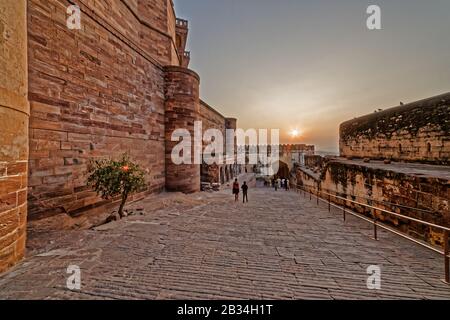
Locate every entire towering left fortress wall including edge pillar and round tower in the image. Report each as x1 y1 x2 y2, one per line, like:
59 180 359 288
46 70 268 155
0 0 239 272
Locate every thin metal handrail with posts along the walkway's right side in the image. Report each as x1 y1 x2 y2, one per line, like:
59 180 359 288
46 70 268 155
297 185 450 284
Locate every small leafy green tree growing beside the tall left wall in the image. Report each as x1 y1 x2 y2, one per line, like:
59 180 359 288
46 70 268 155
88 154 145 218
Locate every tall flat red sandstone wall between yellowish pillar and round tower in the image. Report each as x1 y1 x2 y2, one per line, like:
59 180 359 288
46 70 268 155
28 0 175 218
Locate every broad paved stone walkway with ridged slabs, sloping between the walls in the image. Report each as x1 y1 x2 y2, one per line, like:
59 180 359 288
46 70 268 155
0 188 450 299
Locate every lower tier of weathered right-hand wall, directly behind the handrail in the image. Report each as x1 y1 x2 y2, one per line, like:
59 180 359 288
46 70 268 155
297 161 450 245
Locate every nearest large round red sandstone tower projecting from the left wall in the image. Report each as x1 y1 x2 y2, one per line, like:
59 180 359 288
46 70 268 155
165 66 200 193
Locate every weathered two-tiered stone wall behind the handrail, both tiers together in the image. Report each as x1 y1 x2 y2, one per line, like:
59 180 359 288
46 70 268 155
297 93 450 246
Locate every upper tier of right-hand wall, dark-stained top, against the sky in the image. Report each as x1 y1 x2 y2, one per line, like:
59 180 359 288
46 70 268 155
340 93 450 165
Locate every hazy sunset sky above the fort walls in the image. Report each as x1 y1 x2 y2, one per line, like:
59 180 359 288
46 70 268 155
175 0 450 150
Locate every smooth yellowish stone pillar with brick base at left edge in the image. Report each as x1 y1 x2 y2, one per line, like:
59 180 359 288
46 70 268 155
0 0 29 273
